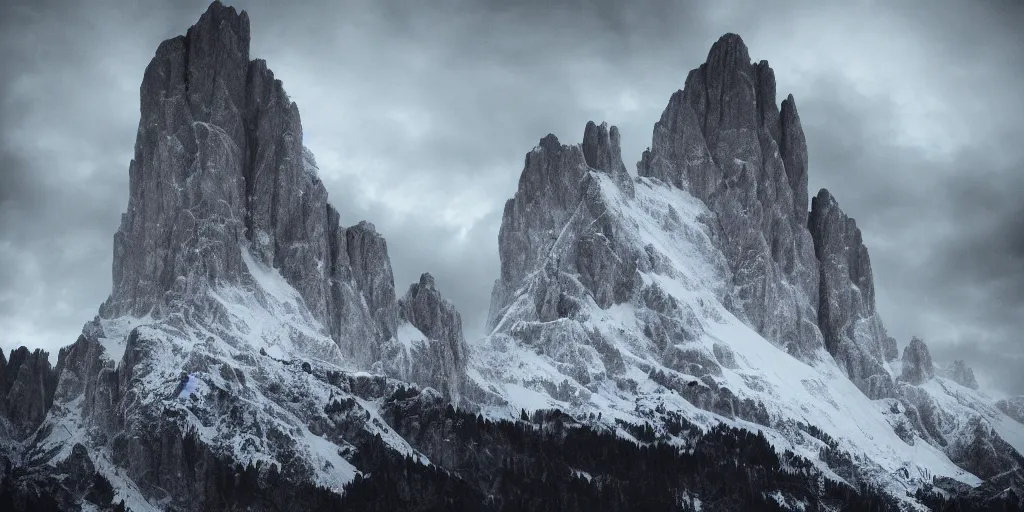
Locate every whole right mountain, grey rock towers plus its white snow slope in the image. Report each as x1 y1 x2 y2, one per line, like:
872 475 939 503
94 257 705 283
479 29 1024 499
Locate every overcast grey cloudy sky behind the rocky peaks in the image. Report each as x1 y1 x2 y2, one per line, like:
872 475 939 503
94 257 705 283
0 0 1024 394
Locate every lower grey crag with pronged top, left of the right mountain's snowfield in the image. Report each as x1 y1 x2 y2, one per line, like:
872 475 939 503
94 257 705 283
490 126 636 325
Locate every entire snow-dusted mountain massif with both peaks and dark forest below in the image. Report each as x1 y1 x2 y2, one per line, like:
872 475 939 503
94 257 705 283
0 2 1024 510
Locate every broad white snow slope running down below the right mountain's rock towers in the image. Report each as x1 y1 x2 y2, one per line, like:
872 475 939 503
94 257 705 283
470 171 991 494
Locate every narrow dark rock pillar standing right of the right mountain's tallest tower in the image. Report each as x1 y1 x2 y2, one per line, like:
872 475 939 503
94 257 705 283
808 189 896 398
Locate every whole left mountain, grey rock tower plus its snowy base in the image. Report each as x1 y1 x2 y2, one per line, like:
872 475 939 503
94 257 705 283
0 1 467 510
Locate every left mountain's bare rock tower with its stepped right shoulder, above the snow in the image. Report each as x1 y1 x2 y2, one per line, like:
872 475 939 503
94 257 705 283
100 1 397 361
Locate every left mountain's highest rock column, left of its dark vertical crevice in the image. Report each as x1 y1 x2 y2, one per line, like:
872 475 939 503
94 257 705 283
103 2 251 316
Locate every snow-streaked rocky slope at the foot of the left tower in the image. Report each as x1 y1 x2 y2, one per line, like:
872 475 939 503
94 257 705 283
34 242 428 503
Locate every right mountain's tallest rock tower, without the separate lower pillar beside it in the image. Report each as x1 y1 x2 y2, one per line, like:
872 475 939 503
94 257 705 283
637 34 822 357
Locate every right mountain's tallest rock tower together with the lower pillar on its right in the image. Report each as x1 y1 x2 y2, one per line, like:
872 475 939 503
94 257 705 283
637 34 897 397
